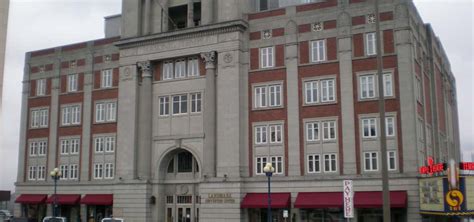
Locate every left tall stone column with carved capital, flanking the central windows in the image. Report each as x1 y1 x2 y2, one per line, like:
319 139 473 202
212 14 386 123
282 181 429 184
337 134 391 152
137 61 153 179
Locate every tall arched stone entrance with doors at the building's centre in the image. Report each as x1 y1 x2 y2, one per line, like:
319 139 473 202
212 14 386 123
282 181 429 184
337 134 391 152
159 148 201 222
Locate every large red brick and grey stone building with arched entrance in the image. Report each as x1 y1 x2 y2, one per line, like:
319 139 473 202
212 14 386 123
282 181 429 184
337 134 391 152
15 0 460 222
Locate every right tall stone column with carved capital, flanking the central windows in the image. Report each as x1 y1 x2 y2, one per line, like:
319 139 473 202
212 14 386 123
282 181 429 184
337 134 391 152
201 51 217 177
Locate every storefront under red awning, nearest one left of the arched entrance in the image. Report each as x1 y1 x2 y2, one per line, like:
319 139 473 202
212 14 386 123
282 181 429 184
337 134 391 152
81 194 114 222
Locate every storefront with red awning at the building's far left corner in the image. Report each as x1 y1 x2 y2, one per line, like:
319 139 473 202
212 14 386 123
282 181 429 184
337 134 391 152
15 194 48 222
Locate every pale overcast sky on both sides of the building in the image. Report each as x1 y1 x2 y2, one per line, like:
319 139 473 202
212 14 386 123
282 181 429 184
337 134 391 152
0 0 474 190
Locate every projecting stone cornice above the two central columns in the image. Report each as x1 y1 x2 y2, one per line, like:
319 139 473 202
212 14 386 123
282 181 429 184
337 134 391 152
115 20 248 49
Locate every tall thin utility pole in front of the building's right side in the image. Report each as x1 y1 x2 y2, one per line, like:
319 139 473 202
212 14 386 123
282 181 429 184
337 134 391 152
374 0 390 222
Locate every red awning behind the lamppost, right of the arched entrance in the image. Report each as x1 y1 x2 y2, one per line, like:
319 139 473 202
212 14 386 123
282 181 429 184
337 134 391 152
240 193 291 208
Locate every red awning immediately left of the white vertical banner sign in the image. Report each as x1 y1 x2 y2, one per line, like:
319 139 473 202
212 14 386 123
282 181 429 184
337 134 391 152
295 192 343 208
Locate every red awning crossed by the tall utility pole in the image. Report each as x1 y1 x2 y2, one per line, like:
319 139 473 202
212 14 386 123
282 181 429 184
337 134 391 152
354 191 407 208
